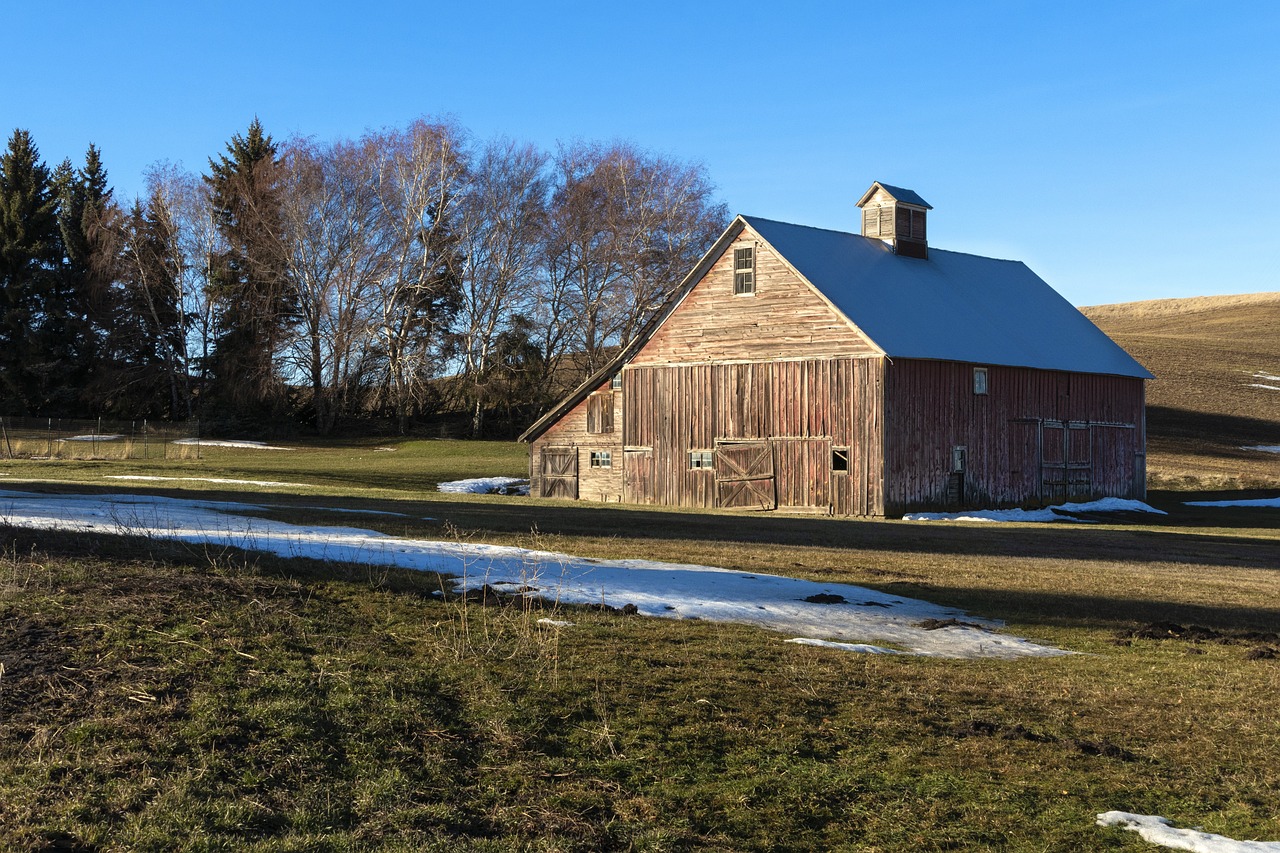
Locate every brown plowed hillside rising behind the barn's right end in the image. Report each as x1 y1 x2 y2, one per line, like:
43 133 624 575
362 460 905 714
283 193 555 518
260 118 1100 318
1080 293 1280 488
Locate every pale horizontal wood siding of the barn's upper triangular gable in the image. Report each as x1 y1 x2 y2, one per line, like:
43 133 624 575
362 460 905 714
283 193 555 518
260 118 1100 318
631 228 878 365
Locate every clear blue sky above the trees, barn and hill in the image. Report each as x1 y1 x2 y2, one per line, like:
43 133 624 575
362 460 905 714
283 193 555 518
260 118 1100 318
0 0 1280 305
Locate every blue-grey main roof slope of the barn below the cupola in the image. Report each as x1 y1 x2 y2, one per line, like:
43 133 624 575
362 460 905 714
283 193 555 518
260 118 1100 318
742 216 1152 379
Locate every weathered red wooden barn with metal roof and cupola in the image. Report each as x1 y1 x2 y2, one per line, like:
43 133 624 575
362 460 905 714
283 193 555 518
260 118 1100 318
521 182 1152 516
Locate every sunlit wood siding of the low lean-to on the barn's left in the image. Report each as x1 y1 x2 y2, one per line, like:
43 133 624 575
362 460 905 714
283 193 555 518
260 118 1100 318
529 382 623 501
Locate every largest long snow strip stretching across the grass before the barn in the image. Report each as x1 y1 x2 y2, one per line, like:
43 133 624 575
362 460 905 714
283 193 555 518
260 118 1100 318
0 489 1068 658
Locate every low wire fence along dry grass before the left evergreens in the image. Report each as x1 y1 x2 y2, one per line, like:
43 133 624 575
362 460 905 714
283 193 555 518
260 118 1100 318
0 418 200 460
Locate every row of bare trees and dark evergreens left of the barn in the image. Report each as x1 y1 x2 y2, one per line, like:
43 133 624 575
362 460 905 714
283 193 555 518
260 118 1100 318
0 119 727 437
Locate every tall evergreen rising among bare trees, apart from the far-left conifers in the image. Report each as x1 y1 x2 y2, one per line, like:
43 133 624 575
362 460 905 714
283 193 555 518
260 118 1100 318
202 118 297 425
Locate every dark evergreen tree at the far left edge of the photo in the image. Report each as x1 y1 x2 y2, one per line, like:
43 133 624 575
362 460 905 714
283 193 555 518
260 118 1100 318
0 129 64 414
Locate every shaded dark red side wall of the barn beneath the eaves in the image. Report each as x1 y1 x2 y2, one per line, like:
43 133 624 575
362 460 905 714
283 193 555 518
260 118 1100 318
884 359 1146 515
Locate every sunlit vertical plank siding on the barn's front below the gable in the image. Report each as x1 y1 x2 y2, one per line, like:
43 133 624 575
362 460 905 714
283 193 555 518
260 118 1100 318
622 357 883 515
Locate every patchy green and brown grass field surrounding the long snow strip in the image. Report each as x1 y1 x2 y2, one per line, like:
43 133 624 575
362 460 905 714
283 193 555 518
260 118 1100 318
0 442 1280 850
